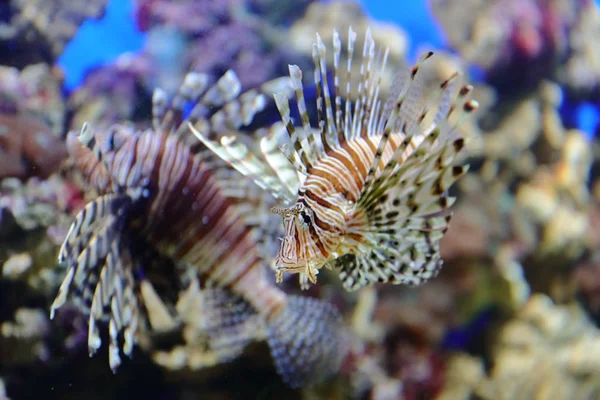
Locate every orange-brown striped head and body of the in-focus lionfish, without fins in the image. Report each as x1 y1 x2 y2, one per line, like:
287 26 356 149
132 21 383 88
275 135 401 272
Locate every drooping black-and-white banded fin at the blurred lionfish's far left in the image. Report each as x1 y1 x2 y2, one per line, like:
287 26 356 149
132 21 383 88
50 194 140 372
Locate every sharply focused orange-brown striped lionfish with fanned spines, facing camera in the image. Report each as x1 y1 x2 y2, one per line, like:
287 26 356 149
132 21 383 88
192 27 478 290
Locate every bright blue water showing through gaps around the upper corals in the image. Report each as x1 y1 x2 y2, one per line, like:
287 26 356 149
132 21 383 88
58 0 600 136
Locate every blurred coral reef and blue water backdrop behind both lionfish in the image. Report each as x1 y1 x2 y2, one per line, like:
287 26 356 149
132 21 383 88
0 0 600 400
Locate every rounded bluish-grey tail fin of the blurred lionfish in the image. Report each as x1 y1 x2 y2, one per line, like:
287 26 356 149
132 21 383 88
267 296 349 388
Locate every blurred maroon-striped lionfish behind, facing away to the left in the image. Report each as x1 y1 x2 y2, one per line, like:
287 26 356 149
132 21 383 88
51 71 347 387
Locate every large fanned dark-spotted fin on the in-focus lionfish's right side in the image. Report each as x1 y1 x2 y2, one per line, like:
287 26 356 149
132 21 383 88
336 53 477 290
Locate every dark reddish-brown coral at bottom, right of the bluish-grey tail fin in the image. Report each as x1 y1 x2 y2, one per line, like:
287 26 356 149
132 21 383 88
349 284 458 399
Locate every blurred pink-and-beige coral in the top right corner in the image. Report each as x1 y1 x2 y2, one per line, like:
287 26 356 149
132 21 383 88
430 0 600 96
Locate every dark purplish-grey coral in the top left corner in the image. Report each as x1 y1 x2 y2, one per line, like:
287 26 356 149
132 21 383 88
0 0 108 68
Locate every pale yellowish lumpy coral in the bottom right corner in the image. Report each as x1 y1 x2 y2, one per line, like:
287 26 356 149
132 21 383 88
438 294 600 400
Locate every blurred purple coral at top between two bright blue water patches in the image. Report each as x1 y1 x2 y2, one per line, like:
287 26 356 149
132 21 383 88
136 0 310 91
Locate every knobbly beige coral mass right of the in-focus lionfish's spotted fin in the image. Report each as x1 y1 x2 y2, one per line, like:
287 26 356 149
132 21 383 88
442 78 594 309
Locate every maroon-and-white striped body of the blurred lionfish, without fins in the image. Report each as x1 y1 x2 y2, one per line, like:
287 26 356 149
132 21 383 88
70 127 284 314
